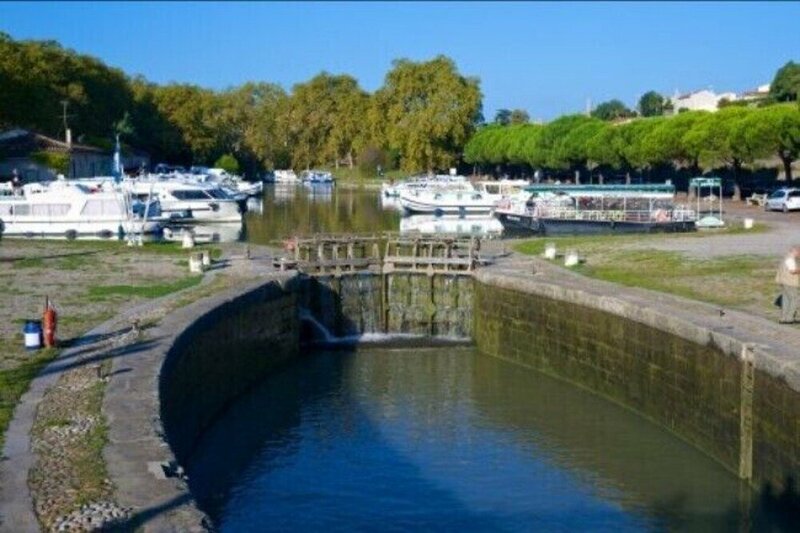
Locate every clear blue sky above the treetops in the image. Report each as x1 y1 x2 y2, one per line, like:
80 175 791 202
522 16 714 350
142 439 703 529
0 2 800 119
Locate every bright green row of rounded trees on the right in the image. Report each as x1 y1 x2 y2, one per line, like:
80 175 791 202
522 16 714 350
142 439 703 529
464 103 800 195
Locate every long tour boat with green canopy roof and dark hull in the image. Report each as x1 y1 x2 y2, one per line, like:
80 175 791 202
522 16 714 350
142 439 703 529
494 184 697 235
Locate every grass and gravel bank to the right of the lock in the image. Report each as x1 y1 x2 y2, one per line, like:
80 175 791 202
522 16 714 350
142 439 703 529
511 198 800 322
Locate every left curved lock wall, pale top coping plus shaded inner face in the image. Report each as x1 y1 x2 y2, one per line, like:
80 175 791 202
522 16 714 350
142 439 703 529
103 273 299 532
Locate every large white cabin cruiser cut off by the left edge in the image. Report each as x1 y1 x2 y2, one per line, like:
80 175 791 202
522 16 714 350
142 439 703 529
0 180 164 239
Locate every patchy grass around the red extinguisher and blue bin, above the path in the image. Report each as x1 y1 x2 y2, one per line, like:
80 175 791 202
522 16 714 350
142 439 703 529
0 239 221 450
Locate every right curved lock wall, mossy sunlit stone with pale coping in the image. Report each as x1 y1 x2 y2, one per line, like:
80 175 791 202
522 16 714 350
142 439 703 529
474 269 800 494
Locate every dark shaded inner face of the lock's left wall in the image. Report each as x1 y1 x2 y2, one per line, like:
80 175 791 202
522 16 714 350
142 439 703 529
159 282 299 463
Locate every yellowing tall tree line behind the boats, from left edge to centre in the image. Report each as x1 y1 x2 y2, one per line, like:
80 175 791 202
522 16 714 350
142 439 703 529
0 33 482 173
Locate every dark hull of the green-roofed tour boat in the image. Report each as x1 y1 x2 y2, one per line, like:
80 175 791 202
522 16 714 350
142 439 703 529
495 213 696 236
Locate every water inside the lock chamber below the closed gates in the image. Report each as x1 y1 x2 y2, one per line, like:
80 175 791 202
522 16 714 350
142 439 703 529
183 346 761 532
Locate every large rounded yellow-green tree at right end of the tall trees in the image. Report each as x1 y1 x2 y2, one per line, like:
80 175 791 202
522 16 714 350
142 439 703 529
374 56 481 170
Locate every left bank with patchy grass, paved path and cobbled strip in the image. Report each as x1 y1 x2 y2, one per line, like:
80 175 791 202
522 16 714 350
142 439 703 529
0 240 262 530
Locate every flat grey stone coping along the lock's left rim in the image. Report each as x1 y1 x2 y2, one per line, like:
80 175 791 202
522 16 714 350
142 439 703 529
103 272 295 532
